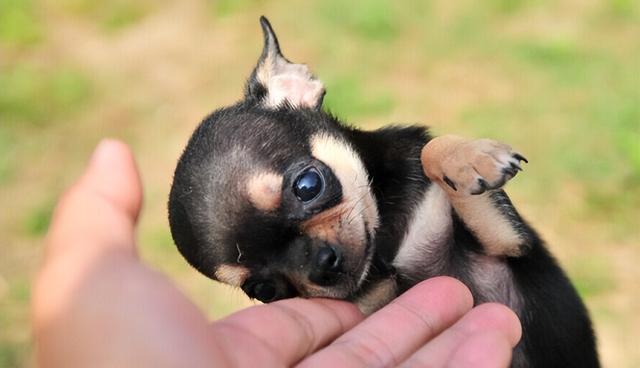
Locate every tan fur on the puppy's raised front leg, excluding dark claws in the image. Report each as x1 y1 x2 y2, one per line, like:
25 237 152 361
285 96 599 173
422 135 523 256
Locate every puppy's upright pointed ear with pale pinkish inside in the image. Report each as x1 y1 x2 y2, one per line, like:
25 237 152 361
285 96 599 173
245 17 325 109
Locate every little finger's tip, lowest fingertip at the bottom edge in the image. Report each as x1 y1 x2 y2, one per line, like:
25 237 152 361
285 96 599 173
446 331 512 368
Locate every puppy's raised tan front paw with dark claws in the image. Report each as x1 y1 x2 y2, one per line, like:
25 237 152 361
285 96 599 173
422 135 527 195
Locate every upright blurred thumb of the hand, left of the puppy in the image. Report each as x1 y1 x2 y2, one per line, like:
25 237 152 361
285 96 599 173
46 140 142 259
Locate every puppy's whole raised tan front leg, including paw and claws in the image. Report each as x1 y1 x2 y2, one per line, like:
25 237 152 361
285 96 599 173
422 135 531 256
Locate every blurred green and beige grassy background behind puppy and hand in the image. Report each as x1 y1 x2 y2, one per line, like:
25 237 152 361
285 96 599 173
0 0 640 367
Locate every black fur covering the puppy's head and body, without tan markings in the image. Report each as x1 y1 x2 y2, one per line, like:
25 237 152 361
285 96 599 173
169 19 599 368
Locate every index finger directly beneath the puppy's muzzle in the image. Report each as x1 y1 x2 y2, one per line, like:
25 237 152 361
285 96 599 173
213 298 363 367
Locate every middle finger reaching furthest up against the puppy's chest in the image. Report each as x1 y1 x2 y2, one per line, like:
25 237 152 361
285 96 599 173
302 277 473 367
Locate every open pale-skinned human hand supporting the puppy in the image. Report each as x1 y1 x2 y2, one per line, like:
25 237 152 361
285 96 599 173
32 140 521 367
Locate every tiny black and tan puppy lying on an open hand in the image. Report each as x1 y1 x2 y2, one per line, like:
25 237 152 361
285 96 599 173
169 18 598 368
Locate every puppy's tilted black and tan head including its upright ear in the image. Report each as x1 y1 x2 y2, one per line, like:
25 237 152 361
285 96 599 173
169 18 378 302
